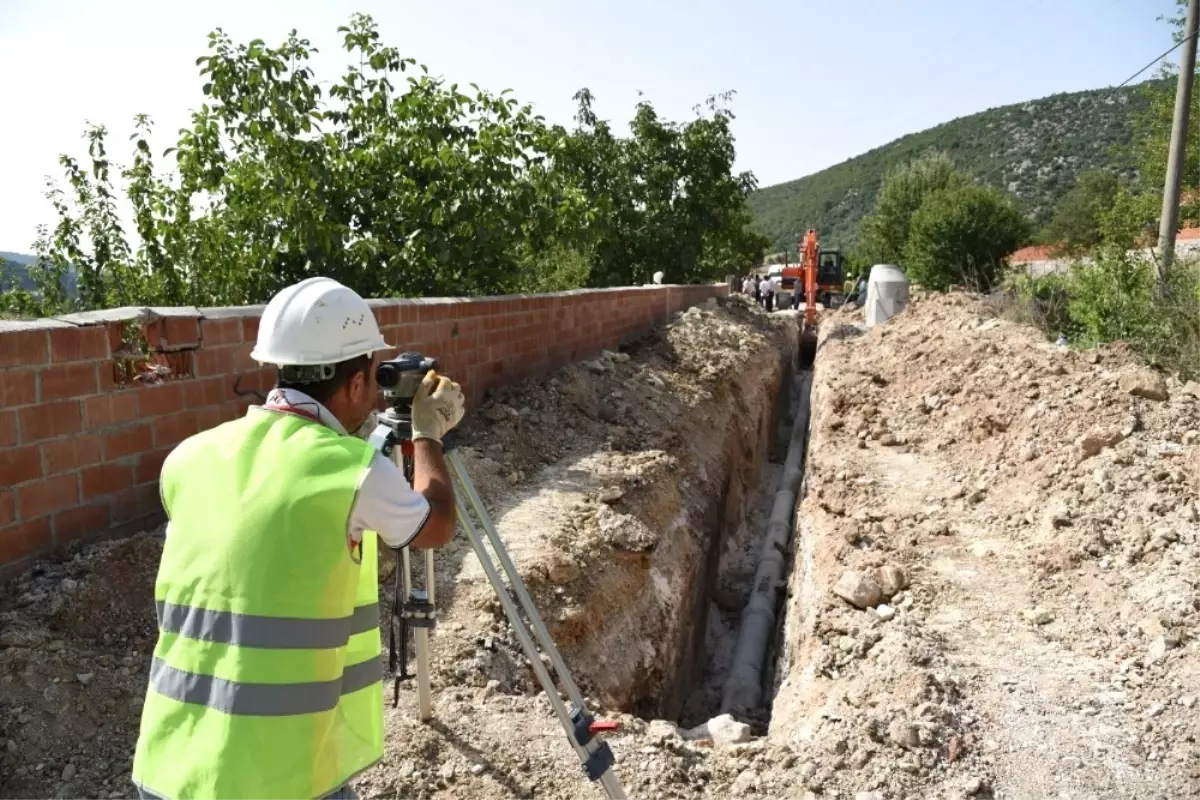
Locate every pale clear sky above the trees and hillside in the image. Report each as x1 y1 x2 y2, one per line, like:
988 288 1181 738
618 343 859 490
0 0 1177 252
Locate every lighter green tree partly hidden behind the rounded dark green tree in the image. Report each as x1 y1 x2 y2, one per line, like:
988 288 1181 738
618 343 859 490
858 152 967 264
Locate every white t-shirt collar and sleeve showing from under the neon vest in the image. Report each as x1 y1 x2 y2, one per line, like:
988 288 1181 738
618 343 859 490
167 389 430 548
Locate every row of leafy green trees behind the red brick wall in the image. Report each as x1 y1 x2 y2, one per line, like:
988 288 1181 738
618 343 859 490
2 14 763 313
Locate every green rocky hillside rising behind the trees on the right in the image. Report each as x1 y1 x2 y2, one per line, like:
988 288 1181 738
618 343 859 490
750 86 1147 246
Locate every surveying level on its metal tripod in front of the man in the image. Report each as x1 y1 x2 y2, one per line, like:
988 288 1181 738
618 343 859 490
367 353 625 800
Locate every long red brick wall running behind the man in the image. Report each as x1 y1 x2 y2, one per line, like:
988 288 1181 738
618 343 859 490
0 285 727 579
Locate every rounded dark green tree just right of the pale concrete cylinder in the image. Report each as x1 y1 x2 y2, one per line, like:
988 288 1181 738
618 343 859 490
904 185 1028 291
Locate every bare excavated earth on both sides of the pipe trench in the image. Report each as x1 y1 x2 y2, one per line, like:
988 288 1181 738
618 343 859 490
0 294 1200 800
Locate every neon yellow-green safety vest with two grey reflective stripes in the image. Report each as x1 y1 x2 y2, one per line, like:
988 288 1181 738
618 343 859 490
133 409 383 800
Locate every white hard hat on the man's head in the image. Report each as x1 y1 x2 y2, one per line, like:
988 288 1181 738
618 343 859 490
250 278 394 366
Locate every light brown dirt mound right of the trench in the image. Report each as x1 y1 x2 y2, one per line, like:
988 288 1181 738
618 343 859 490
772 295 1200 798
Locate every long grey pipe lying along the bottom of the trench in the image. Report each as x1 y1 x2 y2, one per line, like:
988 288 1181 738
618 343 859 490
721 372 812 714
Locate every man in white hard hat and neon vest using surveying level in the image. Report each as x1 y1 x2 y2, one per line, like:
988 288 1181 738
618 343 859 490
133 278 463 800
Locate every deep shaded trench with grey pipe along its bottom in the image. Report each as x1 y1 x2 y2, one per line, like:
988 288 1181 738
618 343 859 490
532 323 812 732
